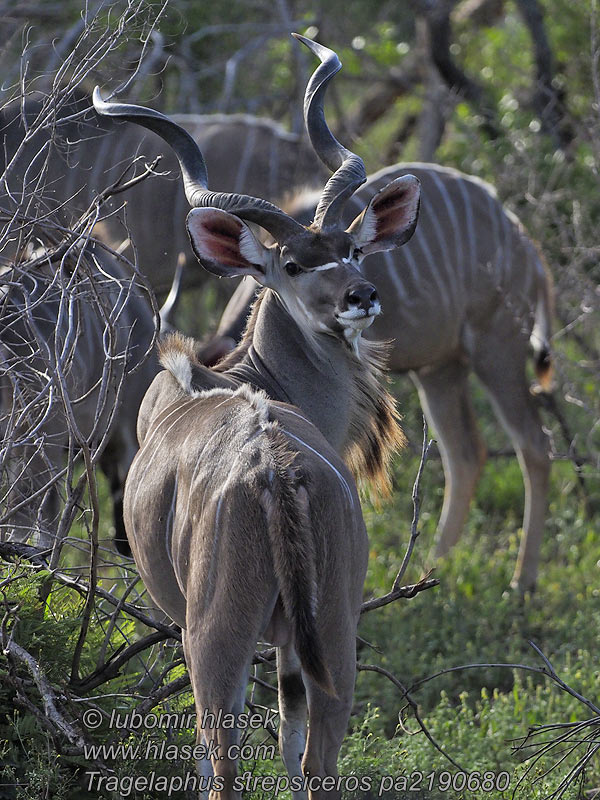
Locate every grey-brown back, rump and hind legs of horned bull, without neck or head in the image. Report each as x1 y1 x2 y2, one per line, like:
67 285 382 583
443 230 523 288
125 338 368 798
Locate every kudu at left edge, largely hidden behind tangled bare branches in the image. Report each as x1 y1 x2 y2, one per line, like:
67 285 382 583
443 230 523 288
0 245 156 552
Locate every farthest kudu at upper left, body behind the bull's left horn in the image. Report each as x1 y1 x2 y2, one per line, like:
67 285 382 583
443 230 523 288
0 96 322 292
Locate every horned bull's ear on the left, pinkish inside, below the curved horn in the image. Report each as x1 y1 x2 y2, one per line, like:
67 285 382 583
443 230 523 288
186 208 268 283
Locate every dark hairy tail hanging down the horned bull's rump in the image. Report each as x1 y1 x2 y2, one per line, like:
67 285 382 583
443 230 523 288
263 426 336 697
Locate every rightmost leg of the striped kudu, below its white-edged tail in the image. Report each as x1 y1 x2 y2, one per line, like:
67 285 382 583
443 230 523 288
475 348 550 593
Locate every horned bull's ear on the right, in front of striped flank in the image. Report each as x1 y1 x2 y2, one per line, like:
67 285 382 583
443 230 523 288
348 175 421 255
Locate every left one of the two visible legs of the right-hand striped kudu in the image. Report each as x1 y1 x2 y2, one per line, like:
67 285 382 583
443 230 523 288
412 361 486 558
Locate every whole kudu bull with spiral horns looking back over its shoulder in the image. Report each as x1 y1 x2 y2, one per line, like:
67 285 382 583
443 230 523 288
95 37 419 800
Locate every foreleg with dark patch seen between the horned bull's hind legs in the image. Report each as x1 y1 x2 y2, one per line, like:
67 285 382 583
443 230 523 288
277 644 307 800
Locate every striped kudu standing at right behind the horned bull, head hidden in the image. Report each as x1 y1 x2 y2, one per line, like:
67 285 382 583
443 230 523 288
200 158 552 591
